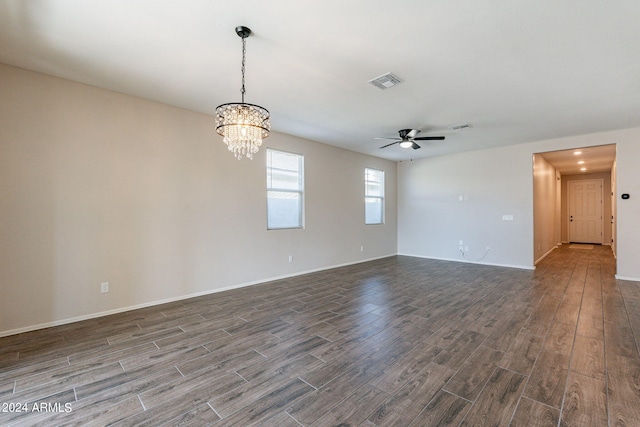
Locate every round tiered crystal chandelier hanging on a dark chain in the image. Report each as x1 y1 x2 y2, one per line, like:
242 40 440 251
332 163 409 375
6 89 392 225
216 27 271 160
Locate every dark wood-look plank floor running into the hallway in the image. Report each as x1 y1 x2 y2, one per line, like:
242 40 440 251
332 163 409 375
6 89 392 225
0 245 640 426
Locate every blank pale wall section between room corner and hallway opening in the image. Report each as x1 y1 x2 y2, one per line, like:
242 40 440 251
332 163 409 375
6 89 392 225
398 145 534 268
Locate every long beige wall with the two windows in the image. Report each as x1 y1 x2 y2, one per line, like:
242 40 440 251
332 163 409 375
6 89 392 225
0 65 397 335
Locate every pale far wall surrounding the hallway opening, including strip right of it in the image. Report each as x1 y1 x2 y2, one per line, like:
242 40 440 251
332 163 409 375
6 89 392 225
398 128 640 281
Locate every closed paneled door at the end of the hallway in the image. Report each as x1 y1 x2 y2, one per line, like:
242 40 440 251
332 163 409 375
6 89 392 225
568 179 602 244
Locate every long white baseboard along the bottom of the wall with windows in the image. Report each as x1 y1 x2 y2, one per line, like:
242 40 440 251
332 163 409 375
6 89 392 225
0 254 397 338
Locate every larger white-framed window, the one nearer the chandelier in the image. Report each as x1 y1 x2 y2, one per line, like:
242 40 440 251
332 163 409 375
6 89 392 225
267 149 304 230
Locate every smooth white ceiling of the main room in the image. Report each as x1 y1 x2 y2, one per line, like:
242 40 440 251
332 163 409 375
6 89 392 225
0 0 640 160
